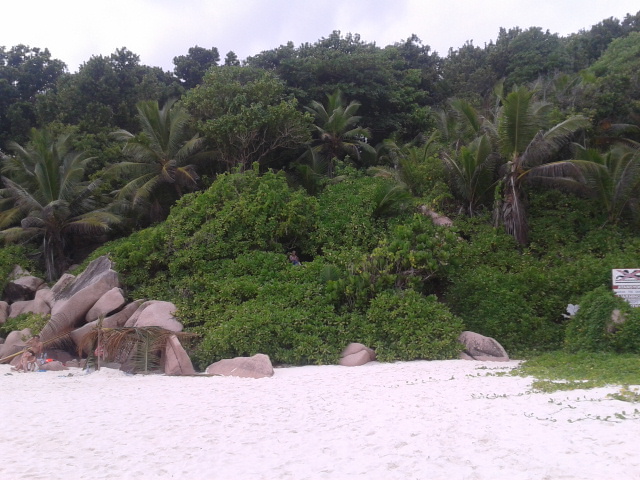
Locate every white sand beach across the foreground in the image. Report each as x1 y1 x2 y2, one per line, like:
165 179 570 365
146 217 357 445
0 360 640 480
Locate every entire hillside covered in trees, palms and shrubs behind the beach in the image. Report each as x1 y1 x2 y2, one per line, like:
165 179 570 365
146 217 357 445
0 12 640 365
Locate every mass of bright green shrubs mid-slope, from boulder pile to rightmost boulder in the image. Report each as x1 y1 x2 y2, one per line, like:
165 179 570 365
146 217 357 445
82 169 463 366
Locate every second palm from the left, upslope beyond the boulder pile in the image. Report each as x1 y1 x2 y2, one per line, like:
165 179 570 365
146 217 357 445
108 100 203 219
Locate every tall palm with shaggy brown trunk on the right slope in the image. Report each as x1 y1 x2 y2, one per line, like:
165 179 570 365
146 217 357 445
496 87 590 244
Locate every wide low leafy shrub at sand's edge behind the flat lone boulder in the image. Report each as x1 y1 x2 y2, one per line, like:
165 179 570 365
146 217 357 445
190 252 357 366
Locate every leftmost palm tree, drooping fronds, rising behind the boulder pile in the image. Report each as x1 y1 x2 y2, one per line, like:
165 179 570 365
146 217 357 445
0 129 120 281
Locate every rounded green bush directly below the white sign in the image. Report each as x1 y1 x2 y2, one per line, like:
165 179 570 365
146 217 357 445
565 286 640 353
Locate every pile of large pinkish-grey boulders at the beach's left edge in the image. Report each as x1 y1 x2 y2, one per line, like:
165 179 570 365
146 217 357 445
0 256 195 375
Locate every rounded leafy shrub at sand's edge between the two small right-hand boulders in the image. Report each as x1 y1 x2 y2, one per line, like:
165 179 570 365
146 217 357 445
365 290 464 361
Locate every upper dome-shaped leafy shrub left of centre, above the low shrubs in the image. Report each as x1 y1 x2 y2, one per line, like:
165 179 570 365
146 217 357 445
166 170 317 274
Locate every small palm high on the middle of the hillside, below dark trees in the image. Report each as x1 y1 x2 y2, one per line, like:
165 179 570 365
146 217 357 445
306 91 373 177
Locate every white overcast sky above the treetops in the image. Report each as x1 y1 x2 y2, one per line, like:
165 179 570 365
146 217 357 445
5 0 640 72
